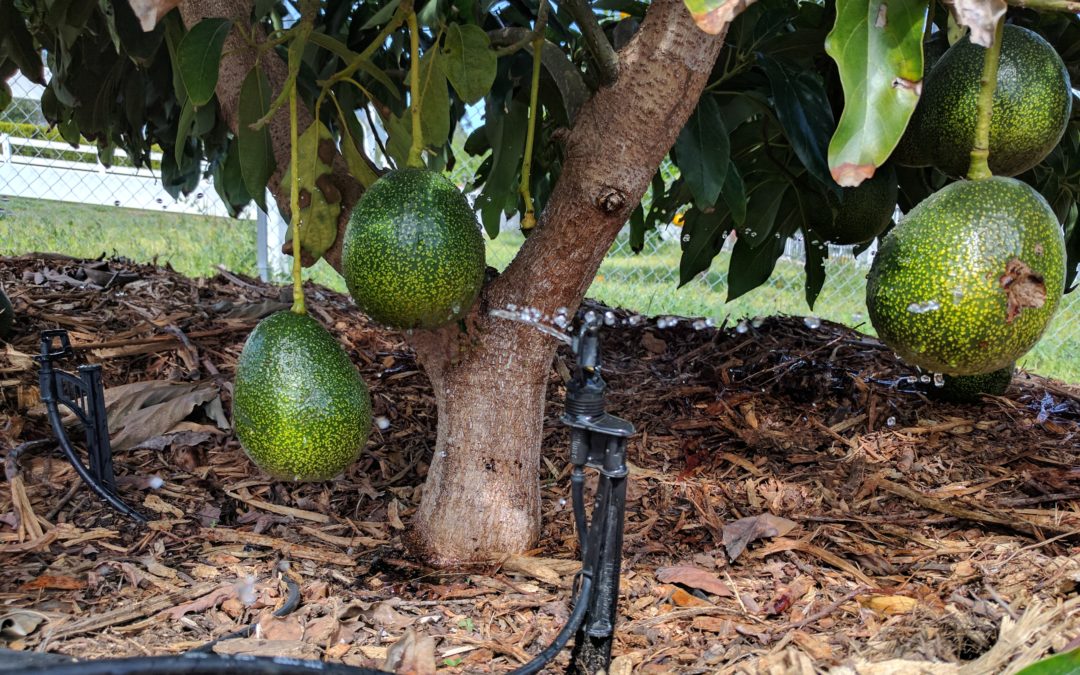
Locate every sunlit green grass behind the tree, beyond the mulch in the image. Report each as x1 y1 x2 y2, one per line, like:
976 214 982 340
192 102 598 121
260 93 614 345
0 199 1080 382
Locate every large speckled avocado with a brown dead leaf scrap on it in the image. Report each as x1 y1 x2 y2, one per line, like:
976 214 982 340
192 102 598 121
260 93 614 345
866 177 1065 375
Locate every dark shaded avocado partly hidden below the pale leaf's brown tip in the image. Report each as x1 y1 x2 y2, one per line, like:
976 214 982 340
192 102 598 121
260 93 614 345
812 164 896 246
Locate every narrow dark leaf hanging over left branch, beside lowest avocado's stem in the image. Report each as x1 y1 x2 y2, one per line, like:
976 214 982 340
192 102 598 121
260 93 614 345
237 66 276 211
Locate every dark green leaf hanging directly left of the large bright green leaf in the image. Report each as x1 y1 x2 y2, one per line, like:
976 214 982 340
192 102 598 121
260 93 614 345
758 55 835 191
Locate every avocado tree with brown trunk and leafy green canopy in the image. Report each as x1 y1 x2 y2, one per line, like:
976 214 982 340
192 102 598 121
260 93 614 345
6 0 1080 564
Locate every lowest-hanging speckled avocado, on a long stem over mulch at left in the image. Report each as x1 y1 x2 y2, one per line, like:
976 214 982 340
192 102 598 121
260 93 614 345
232 311 372 481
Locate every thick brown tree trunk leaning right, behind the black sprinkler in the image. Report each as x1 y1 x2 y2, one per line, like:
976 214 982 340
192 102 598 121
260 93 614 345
181 0 748 565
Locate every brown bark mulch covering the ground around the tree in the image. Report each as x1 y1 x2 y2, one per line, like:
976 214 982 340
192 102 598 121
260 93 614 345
0 256 1080 674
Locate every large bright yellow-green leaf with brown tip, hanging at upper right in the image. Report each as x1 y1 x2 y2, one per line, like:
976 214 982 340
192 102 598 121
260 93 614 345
825 0 927 187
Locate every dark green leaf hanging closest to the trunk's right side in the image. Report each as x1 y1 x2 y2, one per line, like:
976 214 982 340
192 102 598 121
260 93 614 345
674 96 731 208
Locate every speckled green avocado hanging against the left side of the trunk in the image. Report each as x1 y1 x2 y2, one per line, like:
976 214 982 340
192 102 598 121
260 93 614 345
341 168 485 328
